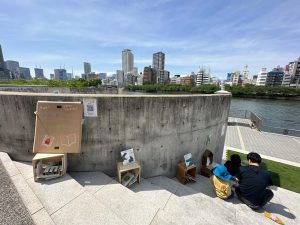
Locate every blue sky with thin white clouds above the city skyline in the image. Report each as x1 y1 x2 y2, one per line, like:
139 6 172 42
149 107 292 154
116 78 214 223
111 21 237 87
0 0 300 78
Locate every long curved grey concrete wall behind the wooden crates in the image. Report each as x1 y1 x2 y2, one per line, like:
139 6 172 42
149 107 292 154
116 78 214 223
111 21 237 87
0 92 231 177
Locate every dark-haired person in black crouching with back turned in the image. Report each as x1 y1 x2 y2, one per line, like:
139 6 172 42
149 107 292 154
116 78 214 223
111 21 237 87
235 152 274 209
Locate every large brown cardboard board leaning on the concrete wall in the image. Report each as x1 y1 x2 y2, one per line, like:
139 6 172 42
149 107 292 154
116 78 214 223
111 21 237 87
33 101 83 153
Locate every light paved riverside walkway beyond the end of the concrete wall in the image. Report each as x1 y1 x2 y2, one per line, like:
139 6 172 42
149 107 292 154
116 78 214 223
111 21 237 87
225 117 300 163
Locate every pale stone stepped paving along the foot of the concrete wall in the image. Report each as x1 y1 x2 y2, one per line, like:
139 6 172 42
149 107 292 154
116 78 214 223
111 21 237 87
0 153 300 225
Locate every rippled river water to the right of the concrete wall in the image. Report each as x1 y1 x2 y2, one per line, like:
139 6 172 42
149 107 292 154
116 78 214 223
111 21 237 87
230 98 300 130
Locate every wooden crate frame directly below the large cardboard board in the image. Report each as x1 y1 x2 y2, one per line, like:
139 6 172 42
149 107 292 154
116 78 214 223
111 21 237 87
32 153 67 181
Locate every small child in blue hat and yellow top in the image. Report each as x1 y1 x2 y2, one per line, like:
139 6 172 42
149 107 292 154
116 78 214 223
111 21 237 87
211 165 236 199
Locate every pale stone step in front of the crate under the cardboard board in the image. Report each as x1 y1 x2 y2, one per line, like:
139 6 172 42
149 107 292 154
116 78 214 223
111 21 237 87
14 162 126 225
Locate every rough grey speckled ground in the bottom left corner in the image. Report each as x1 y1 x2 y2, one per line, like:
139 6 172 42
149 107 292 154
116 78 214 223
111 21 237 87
0 160 34 225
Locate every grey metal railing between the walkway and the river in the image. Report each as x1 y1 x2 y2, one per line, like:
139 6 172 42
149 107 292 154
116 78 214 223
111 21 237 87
229 110 300 137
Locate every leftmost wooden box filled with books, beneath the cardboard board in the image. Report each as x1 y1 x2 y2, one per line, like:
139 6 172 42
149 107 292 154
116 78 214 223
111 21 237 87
32 153 67 181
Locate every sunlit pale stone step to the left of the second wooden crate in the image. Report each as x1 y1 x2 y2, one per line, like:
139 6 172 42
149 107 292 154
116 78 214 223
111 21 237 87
71 172 159 225
